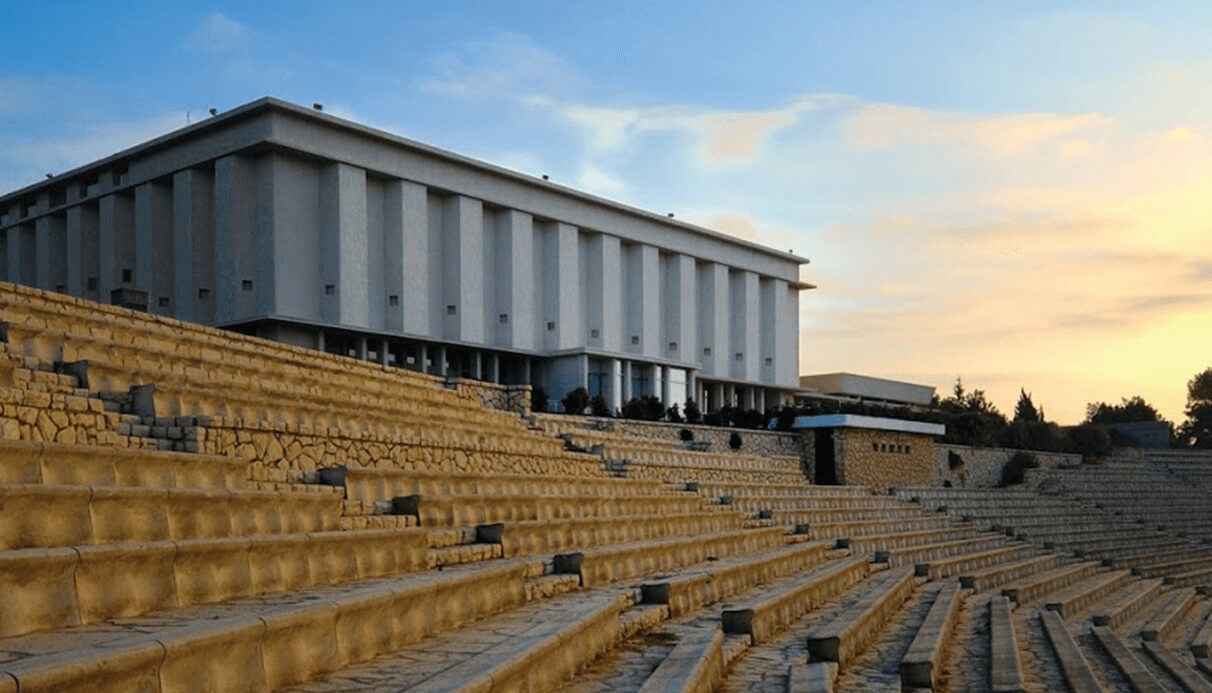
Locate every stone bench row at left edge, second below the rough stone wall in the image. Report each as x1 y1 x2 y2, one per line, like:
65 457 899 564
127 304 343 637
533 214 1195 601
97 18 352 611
0 483 342 550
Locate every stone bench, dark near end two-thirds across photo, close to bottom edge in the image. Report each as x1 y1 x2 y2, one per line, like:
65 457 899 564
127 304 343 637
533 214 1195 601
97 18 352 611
807 568 915 669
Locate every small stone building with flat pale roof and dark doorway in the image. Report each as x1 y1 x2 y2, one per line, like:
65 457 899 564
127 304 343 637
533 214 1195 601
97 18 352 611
795 414 947 488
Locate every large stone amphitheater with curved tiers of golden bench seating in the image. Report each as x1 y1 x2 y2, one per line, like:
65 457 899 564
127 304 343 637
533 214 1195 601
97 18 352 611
0 278 1212 693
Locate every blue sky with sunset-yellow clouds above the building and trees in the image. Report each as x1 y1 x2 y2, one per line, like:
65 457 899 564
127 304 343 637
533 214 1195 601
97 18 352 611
0 1 1212 424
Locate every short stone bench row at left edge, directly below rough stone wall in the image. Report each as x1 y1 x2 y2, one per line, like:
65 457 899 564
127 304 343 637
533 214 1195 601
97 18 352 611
0 441 250 489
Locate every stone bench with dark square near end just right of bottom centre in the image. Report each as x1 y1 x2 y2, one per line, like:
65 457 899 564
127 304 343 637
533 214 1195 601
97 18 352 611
640 542 830 618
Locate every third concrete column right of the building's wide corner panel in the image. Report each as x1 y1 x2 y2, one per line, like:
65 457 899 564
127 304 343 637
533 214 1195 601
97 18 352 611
442 195 484 342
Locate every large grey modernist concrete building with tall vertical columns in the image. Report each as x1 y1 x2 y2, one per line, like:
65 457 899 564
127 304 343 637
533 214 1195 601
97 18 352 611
0 98 811 410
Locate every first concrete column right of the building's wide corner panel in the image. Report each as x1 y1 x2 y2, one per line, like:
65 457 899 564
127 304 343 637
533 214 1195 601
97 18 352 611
318 164 370 327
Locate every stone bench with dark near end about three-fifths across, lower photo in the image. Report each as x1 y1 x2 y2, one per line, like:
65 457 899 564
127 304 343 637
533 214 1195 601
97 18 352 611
720 557 870 643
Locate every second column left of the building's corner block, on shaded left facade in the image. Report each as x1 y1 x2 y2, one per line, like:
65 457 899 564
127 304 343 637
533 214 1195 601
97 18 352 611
135 182 177 315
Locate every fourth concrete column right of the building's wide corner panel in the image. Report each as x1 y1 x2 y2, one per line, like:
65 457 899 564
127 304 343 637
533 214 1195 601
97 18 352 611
490 210 542 349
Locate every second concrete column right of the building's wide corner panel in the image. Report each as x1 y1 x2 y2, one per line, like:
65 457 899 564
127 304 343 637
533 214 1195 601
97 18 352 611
383 181 430 334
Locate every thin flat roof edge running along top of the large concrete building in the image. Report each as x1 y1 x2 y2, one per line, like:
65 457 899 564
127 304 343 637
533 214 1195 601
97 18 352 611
0 96 814 267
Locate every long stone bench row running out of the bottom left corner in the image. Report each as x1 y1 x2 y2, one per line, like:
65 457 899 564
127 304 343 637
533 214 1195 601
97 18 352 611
0 561 530 692
